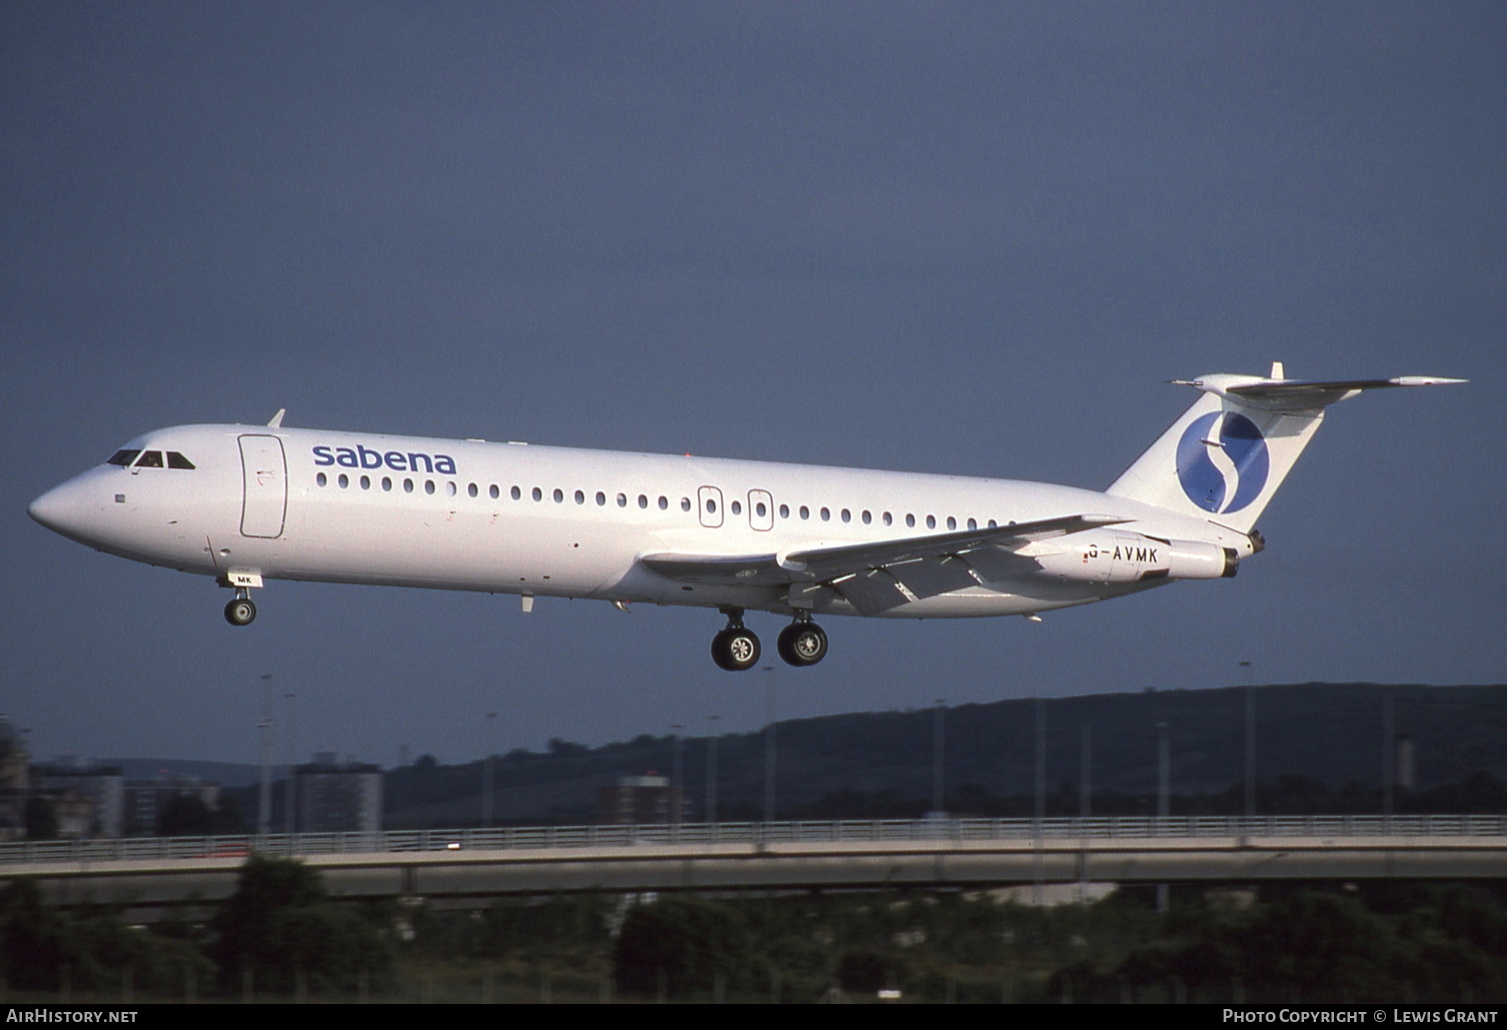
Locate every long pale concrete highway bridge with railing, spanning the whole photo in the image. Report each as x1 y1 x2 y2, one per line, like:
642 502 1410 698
0 816 1507 917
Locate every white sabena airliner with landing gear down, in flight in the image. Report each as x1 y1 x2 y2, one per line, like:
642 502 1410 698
30 363 1465 670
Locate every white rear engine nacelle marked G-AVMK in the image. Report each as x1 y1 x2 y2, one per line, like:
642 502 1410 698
1019 529 1240 584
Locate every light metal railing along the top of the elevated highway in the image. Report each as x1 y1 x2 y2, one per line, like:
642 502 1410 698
0 814 1507 867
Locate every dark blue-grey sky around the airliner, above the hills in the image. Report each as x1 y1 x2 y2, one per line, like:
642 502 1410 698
0 2 1507 763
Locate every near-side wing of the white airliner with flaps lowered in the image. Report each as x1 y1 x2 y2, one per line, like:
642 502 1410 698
639 514 1129 615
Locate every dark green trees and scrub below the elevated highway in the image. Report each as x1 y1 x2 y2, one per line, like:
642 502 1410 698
0 857 1507 1003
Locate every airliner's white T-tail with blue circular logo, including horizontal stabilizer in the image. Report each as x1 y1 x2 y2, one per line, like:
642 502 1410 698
1108 362 1466 532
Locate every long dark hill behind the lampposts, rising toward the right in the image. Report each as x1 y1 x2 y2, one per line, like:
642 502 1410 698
376 683 1507 828
